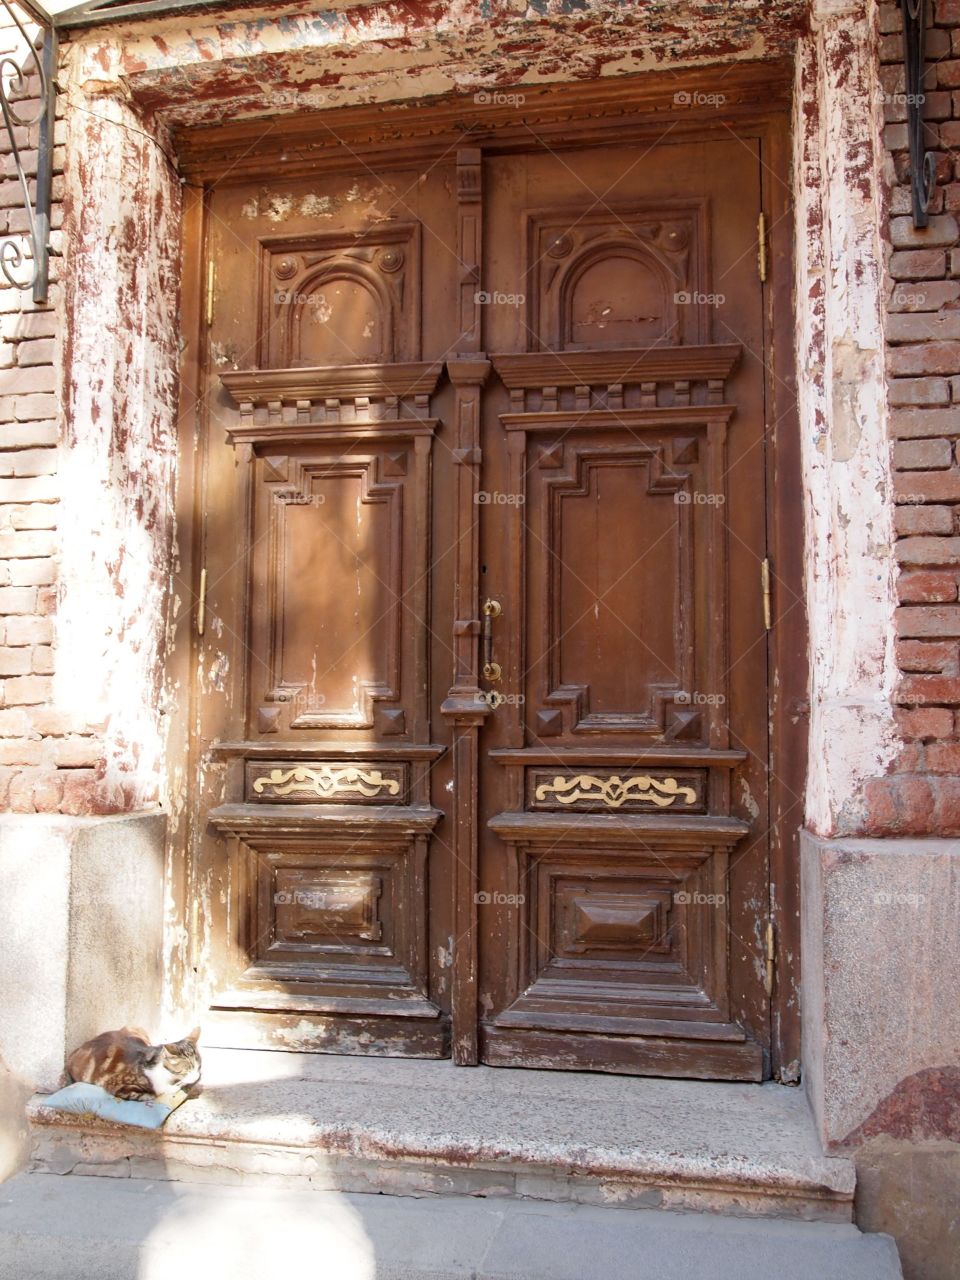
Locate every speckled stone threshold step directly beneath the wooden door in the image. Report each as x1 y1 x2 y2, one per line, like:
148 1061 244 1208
29 1050 855 1222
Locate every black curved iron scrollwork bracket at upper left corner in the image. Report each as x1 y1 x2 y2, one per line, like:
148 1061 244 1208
0 0 56 303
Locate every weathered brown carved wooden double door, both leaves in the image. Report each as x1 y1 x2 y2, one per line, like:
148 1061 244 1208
191 122 771 1079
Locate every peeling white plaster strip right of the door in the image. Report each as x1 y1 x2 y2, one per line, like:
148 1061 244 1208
795 0 897 835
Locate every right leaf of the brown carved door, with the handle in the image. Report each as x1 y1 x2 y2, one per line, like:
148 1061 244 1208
476 136 769 1079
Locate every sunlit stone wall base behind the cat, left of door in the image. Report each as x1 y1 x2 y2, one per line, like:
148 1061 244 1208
0 813 166 1088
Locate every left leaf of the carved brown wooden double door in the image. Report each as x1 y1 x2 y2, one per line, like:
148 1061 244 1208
196 166 457 1056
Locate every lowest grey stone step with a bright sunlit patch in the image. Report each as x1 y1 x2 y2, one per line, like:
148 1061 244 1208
0 1174 902 1280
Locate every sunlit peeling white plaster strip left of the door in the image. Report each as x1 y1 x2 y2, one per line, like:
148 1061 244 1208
54 78 180 813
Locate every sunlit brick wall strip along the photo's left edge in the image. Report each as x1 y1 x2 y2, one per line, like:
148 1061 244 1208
0 10 101 813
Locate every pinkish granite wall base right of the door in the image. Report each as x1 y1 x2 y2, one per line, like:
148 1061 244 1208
801 832 960 1280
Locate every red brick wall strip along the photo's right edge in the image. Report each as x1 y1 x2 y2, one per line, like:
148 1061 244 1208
880 0 960 835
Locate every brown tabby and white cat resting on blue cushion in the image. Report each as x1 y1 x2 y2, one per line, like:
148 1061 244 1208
65 1027 200 1098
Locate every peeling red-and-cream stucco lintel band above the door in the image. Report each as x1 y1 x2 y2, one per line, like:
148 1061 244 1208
60 0 806 125
